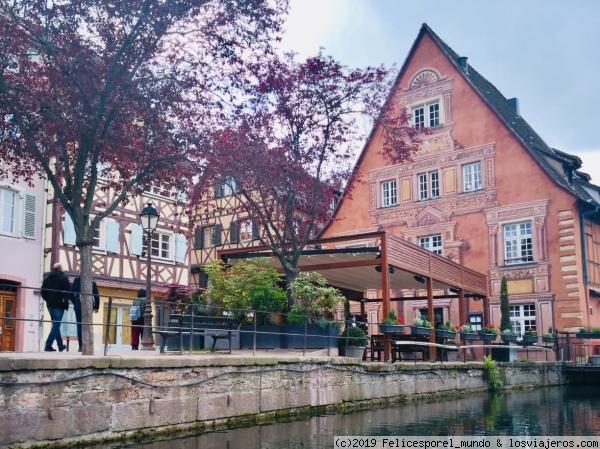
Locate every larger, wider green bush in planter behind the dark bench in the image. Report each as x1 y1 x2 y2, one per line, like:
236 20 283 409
204 259 286 324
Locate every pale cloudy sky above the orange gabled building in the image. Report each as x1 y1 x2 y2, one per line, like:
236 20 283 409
282 0 600 185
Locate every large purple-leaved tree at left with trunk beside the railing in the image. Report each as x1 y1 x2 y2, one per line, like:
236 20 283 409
0 0 287 354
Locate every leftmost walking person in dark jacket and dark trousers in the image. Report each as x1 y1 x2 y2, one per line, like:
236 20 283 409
42 263 71 352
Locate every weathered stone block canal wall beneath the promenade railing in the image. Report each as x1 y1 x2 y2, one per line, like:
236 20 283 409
0 356 563 447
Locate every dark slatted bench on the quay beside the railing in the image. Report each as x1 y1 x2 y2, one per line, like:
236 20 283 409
153 314 240 354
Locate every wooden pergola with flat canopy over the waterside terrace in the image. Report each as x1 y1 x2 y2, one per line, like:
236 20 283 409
218 232 488 360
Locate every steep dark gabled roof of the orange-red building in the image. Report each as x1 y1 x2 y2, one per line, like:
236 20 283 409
324 23 600 234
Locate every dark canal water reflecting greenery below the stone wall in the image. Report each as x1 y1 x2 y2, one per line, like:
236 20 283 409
96 386 600 449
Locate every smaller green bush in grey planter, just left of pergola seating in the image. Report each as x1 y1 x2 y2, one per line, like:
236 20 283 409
288 272 346 323
